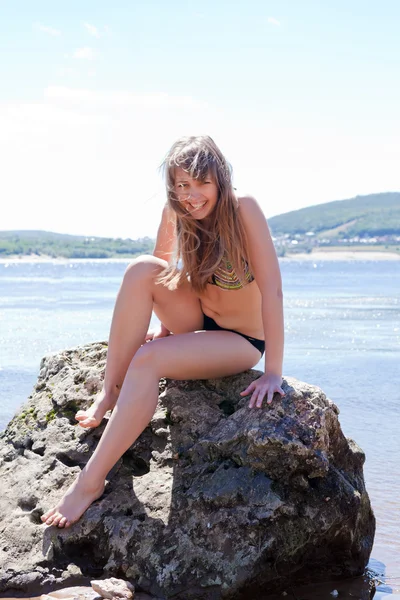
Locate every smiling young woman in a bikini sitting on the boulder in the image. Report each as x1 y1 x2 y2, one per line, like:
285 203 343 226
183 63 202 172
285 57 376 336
42 136 284 527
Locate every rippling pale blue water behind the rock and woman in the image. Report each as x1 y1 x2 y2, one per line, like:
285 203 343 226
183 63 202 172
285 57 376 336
0 259 400 590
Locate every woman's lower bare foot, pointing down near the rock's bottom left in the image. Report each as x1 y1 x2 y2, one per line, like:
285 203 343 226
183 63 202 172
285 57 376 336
41 471 104 527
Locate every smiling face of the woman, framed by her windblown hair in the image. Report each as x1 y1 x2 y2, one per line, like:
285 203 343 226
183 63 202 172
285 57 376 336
174 167 218 219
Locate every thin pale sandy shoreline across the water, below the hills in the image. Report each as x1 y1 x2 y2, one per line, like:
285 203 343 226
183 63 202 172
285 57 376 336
0 249 400 264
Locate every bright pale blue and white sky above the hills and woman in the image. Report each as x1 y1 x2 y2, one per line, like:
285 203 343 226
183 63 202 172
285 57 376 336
0 0 400 237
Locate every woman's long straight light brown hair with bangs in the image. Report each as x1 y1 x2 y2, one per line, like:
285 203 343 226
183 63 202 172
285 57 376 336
159 136 249 293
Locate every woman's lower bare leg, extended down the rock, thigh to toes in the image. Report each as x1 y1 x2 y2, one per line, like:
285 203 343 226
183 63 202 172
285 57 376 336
42 331 260 527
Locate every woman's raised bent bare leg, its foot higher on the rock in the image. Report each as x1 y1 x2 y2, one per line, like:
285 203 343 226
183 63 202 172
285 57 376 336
75 255 203 428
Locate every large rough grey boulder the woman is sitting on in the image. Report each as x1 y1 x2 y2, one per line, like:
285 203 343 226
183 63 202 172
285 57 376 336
0 344 375 600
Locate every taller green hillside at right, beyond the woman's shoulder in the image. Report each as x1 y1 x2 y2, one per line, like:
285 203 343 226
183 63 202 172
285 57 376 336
269 192 400 239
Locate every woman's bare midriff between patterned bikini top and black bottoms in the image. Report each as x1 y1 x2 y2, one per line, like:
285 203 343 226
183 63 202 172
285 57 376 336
199 281 264 340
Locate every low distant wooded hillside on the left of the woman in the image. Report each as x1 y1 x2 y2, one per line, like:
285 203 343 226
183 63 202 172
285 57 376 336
0 231 154 258
